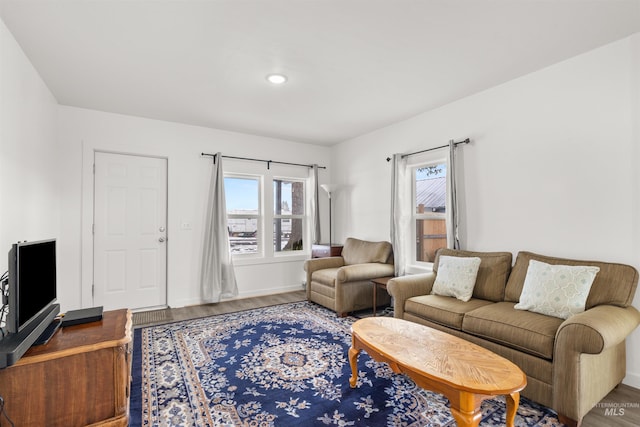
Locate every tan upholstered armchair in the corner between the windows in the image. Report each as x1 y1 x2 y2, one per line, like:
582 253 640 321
304 237 394 317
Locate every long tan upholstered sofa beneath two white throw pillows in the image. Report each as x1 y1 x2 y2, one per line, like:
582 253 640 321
387 249 640 426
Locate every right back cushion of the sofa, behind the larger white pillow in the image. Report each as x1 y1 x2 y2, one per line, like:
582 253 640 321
505 252 638 310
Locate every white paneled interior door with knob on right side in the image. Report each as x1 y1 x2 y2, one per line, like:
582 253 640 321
93 152 167 310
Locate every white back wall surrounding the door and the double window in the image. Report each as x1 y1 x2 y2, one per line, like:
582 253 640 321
58 106 330 309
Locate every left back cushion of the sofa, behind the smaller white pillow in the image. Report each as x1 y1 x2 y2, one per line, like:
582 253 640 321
433 248 513 302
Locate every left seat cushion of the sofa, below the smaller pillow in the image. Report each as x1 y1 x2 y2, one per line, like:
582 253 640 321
404 295 494 330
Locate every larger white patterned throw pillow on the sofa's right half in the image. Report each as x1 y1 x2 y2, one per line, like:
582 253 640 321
514 259 600 319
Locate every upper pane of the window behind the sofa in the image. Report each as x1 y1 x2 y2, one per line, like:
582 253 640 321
415 164 447 213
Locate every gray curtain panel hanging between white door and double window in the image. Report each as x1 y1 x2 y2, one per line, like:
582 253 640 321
200 153 238 303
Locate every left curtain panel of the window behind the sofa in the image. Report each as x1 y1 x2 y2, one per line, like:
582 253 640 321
391 154 411 276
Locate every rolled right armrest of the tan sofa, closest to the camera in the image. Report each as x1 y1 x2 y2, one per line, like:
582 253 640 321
554 305 640 359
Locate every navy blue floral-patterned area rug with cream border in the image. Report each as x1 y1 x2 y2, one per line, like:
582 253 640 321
130 302 561 427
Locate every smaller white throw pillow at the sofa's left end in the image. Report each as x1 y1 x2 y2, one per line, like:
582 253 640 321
431 255 480 301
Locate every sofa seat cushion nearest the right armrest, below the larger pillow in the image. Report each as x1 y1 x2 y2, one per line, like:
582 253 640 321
462 302 564 360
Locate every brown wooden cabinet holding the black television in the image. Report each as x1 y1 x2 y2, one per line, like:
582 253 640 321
0 310 133 427
